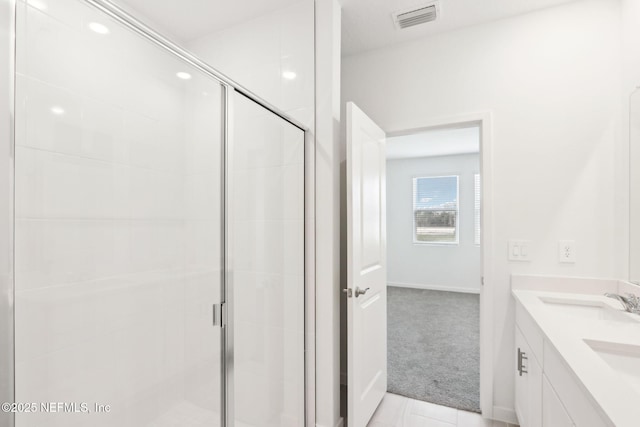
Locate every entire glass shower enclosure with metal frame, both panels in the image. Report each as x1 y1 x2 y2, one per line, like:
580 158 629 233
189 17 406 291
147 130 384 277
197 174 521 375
2 0 305 427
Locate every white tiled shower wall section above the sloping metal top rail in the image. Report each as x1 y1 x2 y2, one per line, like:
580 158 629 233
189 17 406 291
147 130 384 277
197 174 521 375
188 0 314 128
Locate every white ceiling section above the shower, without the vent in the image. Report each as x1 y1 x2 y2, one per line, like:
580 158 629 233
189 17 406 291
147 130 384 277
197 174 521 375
115 0 299 43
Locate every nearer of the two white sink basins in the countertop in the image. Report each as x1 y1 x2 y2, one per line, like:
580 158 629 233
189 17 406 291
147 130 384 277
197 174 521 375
584 340 640 392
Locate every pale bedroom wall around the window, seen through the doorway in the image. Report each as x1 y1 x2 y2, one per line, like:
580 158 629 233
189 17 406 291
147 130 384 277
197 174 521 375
387 154 480 292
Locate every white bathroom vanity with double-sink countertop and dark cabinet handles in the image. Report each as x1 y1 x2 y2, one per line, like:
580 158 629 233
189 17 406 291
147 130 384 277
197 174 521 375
511 276 640 427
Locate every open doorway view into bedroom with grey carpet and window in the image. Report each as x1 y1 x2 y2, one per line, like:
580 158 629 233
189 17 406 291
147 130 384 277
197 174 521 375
386 122 482 412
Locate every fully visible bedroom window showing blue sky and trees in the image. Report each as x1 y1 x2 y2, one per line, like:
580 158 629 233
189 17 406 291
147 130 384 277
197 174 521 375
413 176 458 243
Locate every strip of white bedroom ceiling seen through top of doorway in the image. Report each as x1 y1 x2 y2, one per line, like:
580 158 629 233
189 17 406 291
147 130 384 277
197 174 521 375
387 126 480 159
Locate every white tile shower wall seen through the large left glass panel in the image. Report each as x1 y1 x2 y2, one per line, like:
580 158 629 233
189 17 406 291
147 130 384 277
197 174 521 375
15 0 221 427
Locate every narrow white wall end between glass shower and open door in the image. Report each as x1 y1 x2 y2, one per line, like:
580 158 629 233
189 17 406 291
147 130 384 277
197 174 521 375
316 0 345 427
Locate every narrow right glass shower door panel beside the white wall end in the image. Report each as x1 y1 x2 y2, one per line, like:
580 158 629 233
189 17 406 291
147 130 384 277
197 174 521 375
227 94 305 427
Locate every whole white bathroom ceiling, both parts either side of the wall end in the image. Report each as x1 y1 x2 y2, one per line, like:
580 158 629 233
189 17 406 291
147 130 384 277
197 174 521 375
115 0 575 55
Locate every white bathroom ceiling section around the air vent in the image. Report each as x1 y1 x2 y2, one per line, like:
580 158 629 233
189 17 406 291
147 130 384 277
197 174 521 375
339 0 574 56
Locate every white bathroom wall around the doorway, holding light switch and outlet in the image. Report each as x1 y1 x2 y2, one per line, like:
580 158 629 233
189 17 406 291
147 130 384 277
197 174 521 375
342 0 623 418
